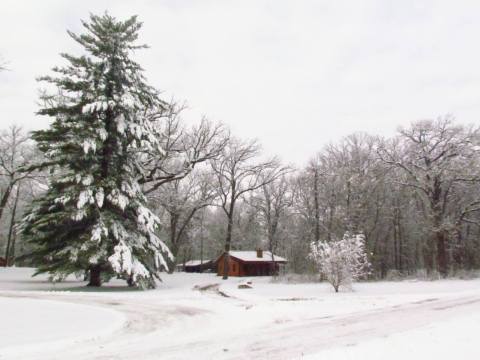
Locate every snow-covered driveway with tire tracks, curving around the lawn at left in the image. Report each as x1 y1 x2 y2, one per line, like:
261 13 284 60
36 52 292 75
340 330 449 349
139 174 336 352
0 292 480 360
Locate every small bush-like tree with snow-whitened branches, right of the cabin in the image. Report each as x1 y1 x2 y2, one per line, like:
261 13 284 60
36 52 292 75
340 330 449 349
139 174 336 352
310 232 371 292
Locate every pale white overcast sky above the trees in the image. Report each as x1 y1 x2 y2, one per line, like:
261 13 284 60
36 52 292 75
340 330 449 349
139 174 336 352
0 0 480 165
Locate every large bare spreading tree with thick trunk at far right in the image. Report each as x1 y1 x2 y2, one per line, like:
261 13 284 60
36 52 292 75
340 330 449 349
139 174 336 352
378 116 480 275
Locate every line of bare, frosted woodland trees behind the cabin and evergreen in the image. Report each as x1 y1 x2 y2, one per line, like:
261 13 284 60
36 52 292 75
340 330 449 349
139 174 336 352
0 112 480 277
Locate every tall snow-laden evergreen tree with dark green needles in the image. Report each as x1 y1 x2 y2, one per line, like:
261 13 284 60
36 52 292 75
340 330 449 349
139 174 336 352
23 14 171 287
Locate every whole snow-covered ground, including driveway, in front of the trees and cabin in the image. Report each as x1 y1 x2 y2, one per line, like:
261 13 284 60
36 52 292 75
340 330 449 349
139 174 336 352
0 268 480 360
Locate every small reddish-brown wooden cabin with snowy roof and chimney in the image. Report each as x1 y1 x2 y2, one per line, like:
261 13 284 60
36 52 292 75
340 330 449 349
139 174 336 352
215 250 287 276
